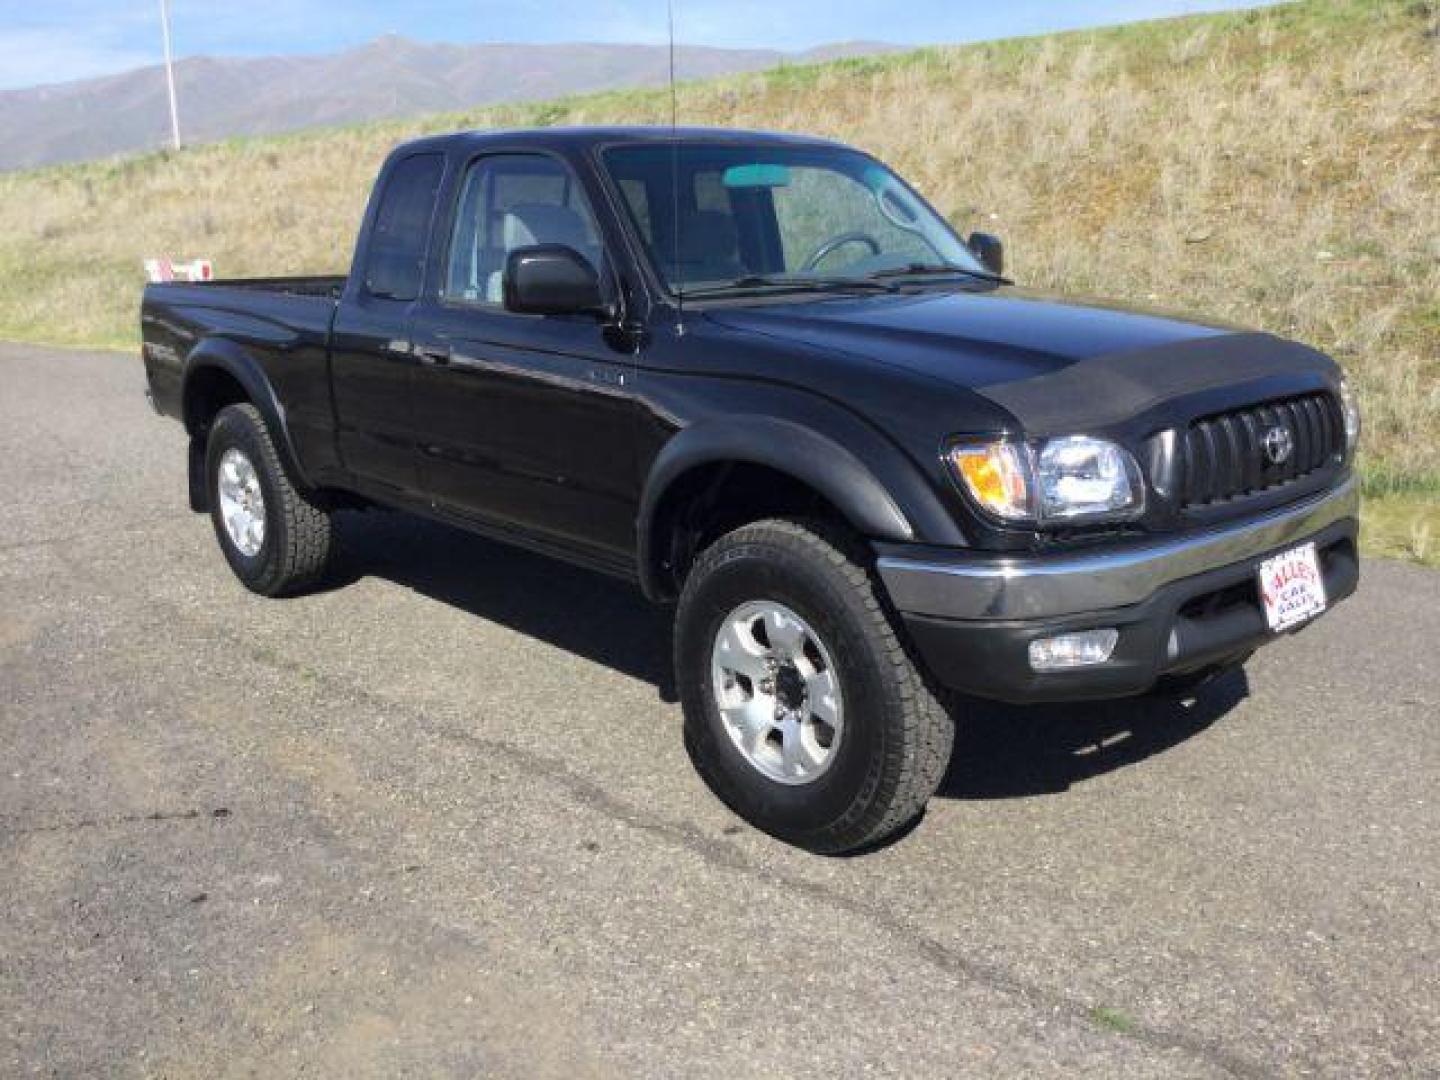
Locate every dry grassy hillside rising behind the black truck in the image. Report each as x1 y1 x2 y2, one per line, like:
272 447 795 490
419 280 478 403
0 0 1440 559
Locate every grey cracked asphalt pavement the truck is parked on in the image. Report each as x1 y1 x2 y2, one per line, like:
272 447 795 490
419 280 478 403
0 346 1440 1077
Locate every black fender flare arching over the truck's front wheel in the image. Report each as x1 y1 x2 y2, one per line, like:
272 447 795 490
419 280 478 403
636 416 916 599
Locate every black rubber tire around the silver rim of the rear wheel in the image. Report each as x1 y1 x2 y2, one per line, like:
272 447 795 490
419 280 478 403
204 405 334 596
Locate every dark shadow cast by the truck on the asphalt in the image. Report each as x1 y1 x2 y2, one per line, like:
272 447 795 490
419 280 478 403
330 513 1248 799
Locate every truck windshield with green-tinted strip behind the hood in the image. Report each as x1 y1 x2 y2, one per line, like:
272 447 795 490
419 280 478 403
605 143 989 295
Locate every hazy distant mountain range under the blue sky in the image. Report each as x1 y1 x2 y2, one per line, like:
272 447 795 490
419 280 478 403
0 35 894 170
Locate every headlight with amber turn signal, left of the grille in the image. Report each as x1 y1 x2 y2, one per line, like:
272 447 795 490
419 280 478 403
946 435 1145 524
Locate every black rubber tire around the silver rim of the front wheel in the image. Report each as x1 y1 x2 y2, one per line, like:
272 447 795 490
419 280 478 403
675 520 955 854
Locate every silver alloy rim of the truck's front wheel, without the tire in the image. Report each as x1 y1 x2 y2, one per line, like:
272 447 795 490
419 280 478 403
710 600 845 785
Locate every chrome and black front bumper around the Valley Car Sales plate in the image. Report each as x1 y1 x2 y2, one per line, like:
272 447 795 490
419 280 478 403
877 478 1359 701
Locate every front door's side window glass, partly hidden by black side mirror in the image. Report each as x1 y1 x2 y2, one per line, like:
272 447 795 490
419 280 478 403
444 154 602 305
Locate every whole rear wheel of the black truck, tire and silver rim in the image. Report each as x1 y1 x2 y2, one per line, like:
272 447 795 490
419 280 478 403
206 405 334 596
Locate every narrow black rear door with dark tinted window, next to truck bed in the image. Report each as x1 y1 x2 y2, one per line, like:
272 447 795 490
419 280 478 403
330 153 445 494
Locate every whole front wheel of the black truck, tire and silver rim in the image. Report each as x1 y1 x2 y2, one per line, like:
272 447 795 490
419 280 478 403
675 520 955 854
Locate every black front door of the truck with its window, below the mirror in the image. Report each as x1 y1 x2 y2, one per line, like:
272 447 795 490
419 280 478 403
415 153 639 564
